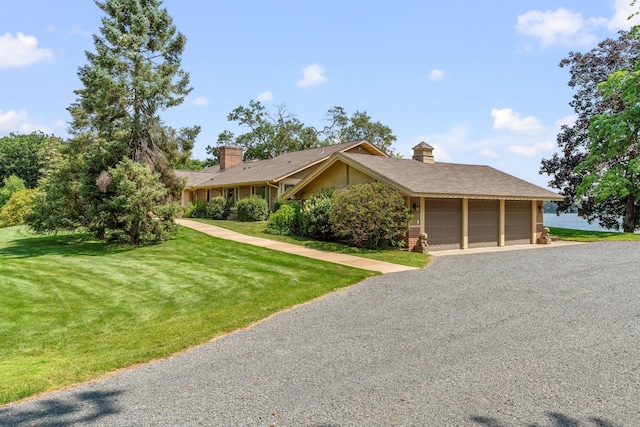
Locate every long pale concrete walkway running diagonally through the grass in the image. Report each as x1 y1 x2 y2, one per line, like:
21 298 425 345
176 219 417 273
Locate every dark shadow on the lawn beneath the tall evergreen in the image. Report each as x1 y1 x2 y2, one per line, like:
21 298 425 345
0 234 132 258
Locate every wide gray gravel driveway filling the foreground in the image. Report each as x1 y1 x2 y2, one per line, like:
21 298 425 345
0 243 640 427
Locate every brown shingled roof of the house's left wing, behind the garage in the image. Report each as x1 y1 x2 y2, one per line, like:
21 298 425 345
176 140 384 188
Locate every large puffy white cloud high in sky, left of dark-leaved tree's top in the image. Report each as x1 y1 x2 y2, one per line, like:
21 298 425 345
516 8 607 47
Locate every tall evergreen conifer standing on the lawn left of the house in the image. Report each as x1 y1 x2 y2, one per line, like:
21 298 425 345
28 0 199 245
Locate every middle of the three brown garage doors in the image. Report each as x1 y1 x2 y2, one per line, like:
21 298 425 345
469 200 500 248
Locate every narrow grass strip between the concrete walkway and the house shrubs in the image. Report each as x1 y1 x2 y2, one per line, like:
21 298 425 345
195 218 431 268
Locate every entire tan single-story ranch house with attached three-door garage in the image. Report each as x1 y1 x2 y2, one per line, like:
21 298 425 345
176 140 563 251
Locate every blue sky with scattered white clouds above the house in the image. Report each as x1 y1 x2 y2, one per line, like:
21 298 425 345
0 0 640 187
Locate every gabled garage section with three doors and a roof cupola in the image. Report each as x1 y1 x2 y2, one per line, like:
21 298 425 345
283 142 563 251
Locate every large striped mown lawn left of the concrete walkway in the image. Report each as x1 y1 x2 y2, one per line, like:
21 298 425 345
0 227 375 404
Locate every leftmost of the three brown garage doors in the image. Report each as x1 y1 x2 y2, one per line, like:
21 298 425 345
425 199 462 251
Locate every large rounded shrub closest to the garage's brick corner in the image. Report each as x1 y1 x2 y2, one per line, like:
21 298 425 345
329 182 411 248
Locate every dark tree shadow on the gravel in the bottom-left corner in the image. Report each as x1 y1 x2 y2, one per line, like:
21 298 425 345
0 391 123 427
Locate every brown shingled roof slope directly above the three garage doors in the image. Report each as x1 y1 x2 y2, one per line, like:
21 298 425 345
335 153 563 200
